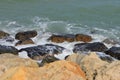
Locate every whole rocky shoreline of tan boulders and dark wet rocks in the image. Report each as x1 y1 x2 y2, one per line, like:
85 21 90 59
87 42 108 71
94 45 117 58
0 30 120 80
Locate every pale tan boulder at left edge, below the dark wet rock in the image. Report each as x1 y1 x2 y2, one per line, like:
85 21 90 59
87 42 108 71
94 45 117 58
0 53 38 76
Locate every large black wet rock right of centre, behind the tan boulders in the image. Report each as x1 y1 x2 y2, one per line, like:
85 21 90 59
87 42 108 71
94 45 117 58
73 42 108 53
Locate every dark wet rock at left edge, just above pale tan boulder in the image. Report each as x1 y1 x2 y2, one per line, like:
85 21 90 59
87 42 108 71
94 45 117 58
0 45 18 55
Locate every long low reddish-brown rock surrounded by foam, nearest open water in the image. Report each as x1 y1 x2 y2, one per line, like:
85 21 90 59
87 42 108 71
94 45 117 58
48 34 92 43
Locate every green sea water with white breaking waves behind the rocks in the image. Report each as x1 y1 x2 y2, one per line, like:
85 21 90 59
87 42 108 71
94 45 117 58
0 0 120 39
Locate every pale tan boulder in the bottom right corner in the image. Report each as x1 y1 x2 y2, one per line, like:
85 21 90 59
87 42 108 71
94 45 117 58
94 61 120 80
